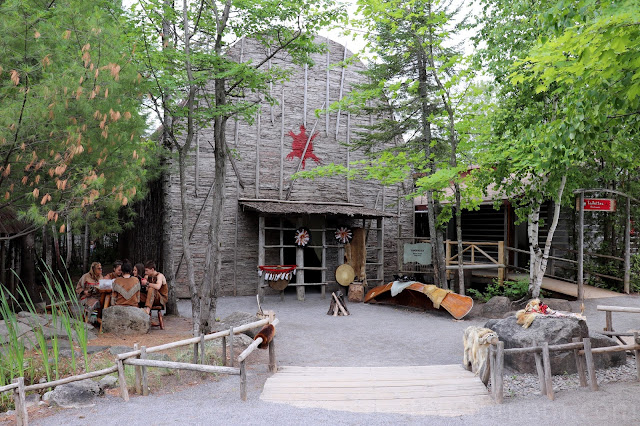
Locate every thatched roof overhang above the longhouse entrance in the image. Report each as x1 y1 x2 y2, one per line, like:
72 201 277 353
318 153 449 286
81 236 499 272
238 199 396 219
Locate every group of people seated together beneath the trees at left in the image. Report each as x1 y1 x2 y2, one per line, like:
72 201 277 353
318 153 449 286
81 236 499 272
76 260 169 322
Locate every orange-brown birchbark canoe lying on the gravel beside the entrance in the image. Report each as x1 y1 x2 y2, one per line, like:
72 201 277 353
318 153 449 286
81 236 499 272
364 283 473 319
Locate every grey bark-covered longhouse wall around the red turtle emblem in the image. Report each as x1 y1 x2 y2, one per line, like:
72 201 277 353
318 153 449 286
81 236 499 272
171 38 413 296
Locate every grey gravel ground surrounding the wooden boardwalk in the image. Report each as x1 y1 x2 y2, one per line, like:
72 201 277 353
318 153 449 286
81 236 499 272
32 293 640 426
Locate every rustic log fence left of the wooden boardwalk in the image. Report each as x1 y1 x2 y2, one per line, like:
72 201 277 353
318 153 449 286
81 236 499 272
0 318 280 426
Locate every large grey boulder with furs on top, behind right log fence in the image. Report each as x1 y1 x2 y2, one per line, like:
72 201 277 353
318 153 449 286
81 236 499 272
485 316 626 374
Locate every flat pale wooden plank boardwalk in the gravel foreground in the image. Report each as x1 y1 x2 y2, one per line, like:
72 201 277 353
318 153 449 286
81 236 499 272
260 365 494 416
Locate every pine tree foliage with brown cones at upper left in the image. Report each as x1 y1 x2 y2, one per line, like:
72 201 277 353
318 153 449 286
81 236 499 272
0 0 154 232
